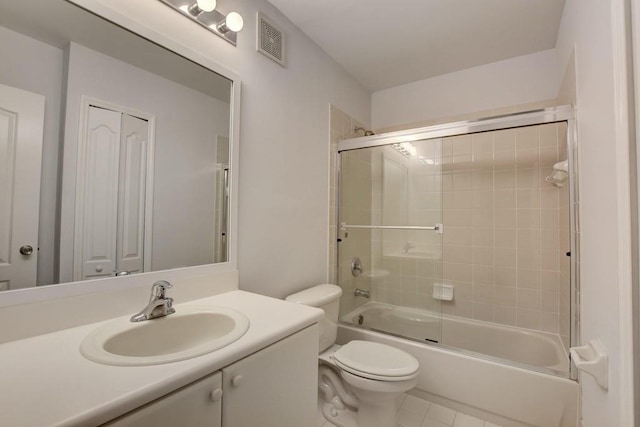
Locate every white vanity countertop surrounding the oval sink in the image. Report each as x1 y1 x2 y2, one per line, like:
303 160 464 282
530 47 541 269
0 291 323 427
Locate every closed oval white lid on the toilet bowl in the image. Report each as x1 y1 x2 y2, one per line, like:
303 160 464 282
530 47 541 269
333 340 420 381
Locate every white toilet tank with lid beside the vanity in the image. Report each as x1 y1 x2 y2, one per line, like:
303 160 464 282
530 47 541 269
285 284 342 352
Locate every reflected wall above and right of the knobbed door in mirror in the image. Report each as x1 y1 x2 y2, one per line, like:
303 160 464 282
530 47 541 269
0 27 63 285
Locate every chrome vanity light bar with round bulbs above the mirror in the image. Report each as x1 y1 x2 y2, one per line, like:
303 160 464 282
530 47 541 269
160 0 244 46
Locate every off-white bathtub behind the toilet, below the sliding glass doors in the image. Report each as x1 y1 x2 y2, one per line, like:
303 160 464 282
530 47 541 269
338 302 578 427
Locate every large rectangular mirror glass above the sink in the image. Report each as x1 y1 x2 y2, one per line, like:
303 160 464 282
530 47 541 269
0 0 234 290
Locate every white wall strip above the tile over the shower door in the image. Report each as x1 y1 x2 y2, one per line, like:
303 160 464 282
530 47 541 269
371 49 559 129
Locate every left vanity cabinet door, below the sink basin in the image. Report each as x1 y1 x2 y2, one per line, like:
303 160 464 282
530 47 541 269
104 372 222 427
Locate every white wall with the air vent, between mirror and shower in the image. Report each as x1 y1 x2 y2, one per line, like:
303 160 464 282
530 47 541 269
67 0 370 297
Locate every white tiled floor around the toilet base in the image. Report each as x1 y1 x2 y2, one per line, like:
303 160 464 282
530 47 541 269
317 396 500 427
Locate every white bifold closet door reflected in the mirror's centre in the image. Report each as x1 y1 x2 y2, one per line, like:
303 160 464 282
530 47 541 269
74 106 149 280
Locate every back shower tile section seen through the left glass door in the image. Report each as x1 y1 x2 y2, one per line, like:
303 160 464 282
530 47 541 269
371 145 442 312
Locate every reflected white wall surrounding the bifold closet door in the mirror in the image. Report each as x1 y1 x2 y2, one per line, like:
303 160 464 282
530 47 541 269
61 43 229 282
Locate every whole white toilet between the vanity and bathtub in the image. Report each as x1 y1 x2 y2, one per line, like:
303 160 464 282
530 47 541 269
286 284 420 427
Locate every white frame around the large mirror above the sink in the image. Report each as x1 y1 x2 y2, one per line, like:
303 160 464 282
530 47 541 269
0 0 241 308
